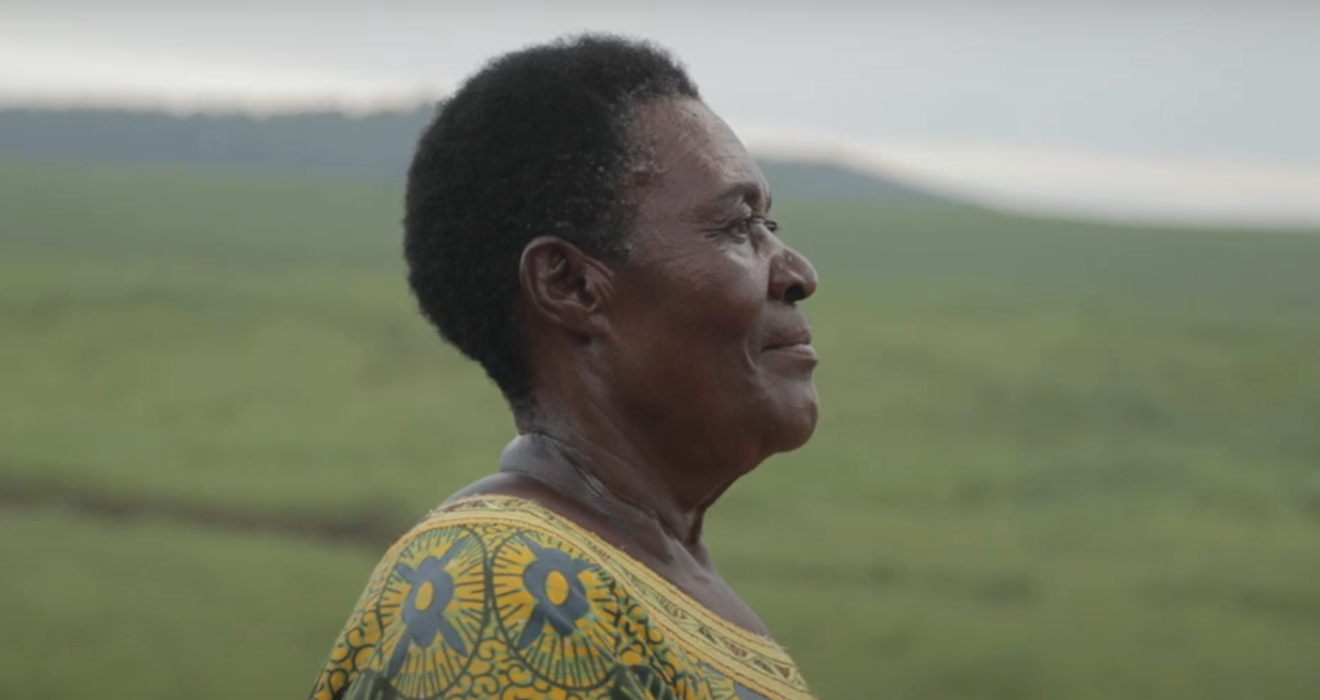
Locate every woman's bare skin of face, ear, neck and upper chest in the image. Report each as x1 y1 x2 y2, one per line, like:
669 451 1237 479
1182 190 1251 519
454 93 817 633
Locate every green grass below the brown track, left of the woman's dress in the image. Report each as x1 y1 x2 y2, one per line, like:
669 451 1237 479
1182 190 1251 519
0 510 374 700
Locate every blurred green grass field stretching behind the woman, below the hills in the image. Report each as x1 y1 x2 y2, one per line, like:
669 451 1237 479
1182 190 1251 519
0 157 1320 700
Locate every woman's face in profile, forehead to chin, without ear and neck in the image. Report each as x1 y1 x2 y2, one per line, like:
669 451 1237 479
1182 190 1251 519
610 99 817 465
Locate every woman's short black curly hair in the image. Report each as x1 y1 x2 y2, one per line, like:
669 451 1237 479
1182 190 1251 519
404 34 701 411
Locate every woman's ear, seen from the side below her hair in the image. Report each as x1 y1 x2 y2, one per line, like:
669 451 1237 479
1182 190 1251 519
519 236 614 335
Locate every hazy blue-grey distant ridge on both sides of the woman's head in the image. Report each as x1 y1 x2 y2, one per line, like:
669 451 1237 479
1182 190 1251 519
0 107 945 205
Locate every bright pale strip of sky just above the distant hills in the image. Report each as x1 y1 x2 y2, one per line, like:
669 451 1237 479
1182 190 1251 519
0 87 1320 228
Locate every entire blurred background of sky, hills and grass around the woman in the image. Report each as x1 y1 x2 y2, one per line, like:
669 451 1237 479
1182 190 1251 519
0 0 1320 700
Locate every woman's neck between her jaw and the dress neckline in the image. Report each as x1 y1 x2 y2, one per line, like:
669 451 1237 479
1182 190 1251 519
500 388 734 559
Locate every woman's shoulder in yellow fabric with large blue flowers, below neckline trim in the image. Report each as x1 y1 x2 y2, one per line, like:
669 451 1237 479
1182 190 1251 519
313 499 702 700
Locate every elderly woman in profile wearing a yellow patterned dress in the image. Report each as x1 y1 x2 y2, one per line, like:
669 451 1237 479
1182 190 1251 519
312 36 817 700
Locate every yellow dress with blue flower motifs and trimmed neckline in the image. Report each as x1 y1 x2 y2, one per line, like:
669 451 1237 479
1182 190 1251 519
310 497 813 700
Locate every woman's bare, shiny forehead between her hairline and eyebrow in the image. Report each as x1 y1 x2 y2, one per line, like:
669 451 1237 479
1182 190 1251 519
636 99 770 211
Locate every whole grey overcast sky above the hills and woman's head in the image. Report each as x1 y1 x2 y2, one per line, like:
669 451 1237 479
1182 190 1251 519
0 0 1320 222
